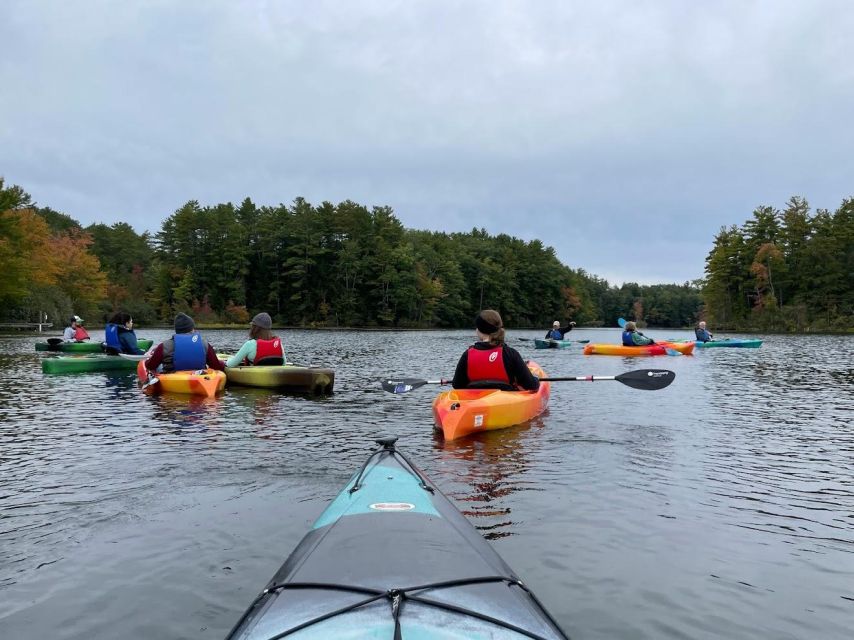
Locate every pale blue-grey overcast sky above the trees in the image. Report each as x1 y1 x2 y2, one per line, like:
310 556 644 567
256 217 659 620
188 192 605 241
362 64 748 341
0 0 854 284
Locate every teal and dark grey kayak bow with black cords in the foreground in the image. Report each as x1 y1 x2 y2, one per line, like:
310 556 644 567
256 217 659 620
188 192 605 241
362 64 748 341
228 438 567 640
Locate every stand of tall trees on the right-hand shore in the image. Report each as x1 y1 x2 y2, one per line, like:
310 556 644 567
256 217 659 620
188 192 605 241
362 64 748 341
703 197 854 331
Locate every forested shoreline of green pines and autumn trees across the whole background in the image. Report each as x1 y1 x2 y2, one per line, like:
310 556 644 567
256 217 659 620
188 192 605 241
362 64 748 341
0 178 852 330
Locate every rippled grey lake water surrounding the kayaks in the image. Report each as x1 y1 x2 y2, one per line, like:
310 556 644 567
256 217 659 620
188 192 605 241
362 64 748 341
0 329 854 640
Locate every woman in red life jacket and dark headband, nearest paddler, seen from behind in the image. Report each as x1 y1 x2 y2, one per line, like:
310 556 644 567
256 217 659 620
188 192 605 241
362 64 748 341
452 309 540 391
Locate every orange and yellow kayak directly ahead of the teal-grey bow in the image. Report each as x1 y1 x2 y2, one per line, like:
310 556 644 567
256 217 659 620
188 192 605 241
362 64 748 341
433 360 550 440
